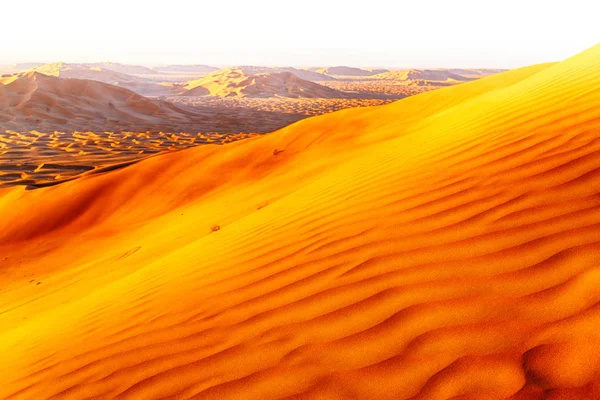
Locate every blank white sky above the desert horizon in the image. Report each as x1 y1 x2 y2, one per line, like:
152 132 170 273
0 0 600 68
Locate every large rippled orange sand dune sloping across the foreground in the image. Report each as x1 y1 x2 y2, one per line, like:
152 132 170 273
0 45 600 400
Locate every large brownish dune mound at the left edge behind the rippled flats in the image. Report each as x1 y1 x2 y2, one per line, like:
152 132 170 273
0 72 192 131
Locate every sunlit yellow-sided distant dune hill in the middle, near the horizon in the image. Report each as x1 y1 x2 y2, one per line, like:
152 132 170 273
184 68 348 98
